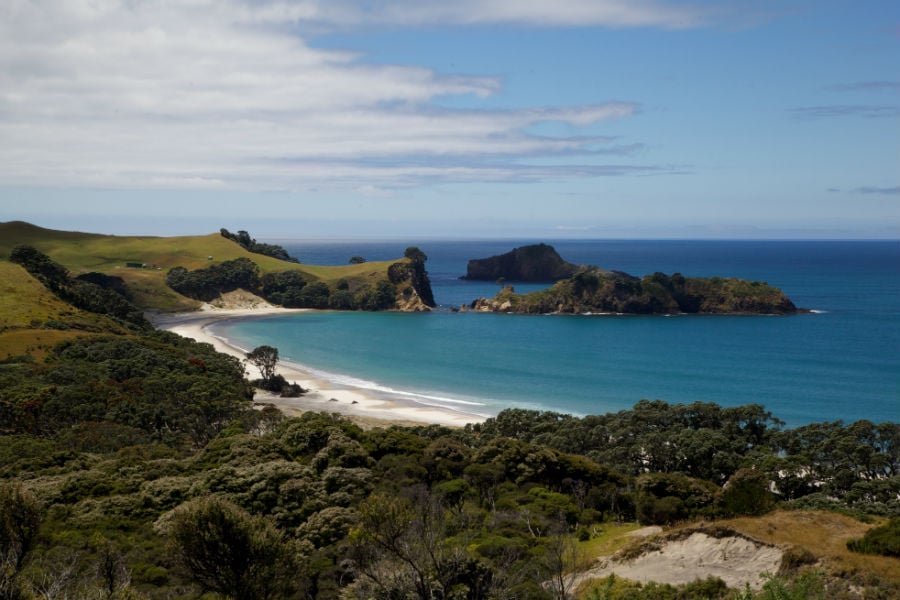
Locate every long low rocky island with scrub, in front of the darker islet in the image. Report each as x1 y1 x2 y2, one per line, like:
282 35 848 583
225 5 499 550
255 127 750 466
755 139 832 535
468 246 802 315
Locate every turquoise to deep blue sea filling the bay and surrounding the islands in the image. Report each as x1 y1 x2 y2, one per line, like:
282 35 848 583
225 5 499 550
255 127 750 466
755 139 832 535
213 240 900 427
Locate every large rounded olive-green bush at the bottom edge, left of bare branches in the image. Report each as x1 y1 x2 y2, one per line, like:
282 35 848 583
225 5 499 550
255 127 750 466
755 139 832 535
170 497 296 600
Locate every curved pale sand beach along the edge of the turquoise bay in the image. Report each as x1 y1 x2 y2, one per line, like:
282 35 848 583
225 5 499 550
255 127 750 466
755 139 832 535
148 305 485 427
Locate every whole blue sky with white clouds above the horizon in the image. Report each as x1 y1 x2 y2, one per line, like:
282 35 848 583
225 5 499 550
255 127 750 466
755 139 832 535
0 0 900 239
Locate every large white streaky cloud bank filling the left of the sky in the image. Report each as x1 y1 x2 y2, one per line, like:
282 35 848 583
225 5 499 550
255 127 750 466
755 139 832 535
0 0 680 189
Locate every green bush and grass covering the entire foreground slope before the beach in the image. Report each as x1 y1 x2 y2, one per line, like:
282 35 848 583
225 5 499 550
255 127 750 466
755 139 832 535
0 227 900 600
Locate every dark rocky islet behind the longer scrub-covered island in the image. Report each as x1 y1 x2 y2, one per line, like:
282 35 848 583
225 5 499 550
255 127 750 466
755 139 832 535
461 244 584 282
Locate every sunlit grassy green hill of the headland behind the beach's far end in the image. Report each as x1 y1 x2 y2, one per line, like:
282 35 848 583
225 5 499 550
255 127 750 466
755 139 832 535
0 221 400 312
